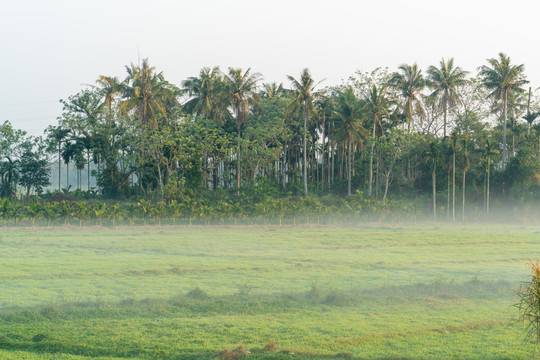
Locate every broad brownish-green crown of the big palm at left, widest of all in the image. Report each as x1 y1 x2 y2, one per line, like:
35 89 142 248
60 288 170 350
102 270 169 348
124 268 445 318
119 59 177 128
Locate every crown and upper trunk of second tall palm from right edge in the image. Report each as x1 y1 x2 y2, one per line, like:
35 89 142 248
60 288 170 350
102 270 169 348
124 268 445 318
427 58 467 137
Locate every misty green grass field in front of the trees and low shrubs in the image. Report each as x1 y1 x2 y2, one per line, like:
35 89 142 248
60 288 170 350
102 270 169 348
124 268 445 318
0 224 540 359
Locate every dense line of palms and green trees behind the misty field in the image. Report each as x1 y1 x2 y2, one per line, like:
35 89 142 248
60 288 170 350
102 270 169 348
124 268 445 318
0 53 540 220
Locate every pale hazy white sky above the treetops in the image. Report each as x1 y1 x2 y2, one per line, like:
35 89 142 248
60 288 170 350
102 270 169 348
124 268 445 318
0 0 540 134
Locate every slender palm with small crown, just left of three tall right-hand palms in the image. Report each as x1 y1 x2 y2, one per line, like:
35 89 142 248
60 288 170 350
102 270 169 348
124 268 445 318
365 84 393 197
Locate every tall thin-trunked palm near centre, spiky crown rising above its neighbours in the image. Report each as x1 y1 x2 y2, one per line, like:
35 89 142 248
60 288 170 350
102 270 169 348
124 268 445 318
287 69 318 196
